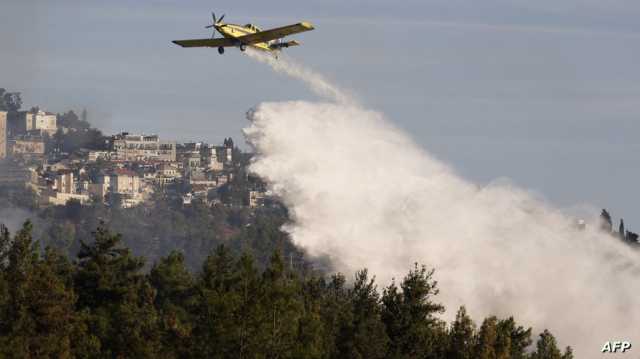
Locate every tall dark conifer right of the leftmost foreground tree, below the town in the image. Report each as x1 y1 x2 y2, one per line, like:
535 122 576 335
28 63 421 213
74 224 160 358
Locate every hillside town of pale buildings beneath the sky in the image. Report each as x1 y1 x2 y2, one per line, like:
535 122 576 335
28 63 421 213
0 89 267 208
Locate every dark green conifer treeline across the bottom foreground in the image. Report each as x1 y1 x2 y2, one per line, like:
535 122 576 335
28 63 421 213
0 222 572 359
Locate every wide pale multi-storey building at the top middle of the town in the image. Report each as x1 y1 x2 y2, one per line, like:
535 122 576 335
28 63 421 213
112 132 176 162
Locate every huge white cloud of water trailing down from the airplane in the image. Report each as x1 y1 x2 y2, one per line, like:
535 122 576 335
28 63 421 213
244 50 640 358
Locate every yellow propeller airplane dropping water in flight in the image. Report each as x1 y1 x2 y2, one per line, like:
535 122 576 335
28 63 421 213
173 13 313 55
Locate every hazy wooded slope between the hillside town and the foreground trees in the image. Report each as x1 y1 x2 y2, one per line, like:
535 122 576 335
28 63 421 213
0 184 316 271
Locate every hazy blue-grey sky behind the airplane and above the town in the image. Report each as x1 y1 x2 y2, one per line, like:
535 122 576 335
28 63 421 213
0 0 640 225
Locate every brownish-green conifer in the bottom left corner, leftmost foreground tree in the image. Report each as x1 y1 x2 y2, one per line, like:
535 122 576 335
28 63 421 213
0 222 91 358
